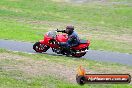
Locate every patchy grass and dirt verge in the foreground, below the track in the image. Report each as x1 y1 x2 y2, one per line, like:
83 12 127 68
0 49 132 88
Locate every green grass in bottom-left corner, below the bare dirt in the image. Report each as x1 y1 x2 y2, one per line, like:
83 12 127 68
0 71 78 88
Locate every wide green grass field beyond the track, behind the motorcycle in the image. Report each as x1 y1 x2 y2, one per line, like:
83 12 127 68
0 0 132 53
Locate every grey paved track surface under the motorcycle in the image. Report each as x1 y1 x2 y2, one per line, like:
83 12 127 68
0 39 132 66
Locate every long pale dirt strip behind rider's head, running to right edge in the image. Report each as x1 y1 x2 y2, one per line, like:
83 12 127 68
14 20 132 43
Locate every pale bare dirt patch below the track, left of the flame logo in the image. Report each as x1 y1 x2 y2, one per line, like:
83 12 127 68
0 53 89 83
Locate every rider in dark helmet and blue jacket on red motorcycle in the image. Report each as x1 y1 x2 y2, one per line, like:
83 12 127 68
60 26 80 55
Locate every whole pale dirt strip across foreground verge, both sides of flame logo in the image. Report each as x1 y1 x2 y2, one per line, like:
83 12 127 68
0 53 132 83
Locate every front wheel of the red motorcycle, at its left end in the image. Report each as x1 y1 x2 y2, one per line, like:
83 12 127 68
33 42 50 53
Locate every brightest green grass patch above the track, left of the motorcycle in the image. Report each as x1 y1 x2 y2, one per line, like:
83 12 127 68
0 19 47 42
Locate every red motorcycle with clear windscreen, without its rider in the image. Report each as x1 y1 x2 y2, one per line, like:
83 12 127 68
33 30 90 57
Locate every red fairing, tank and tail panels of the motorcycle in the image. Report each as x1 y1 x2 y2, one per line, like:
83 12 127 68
39 34 90 50
